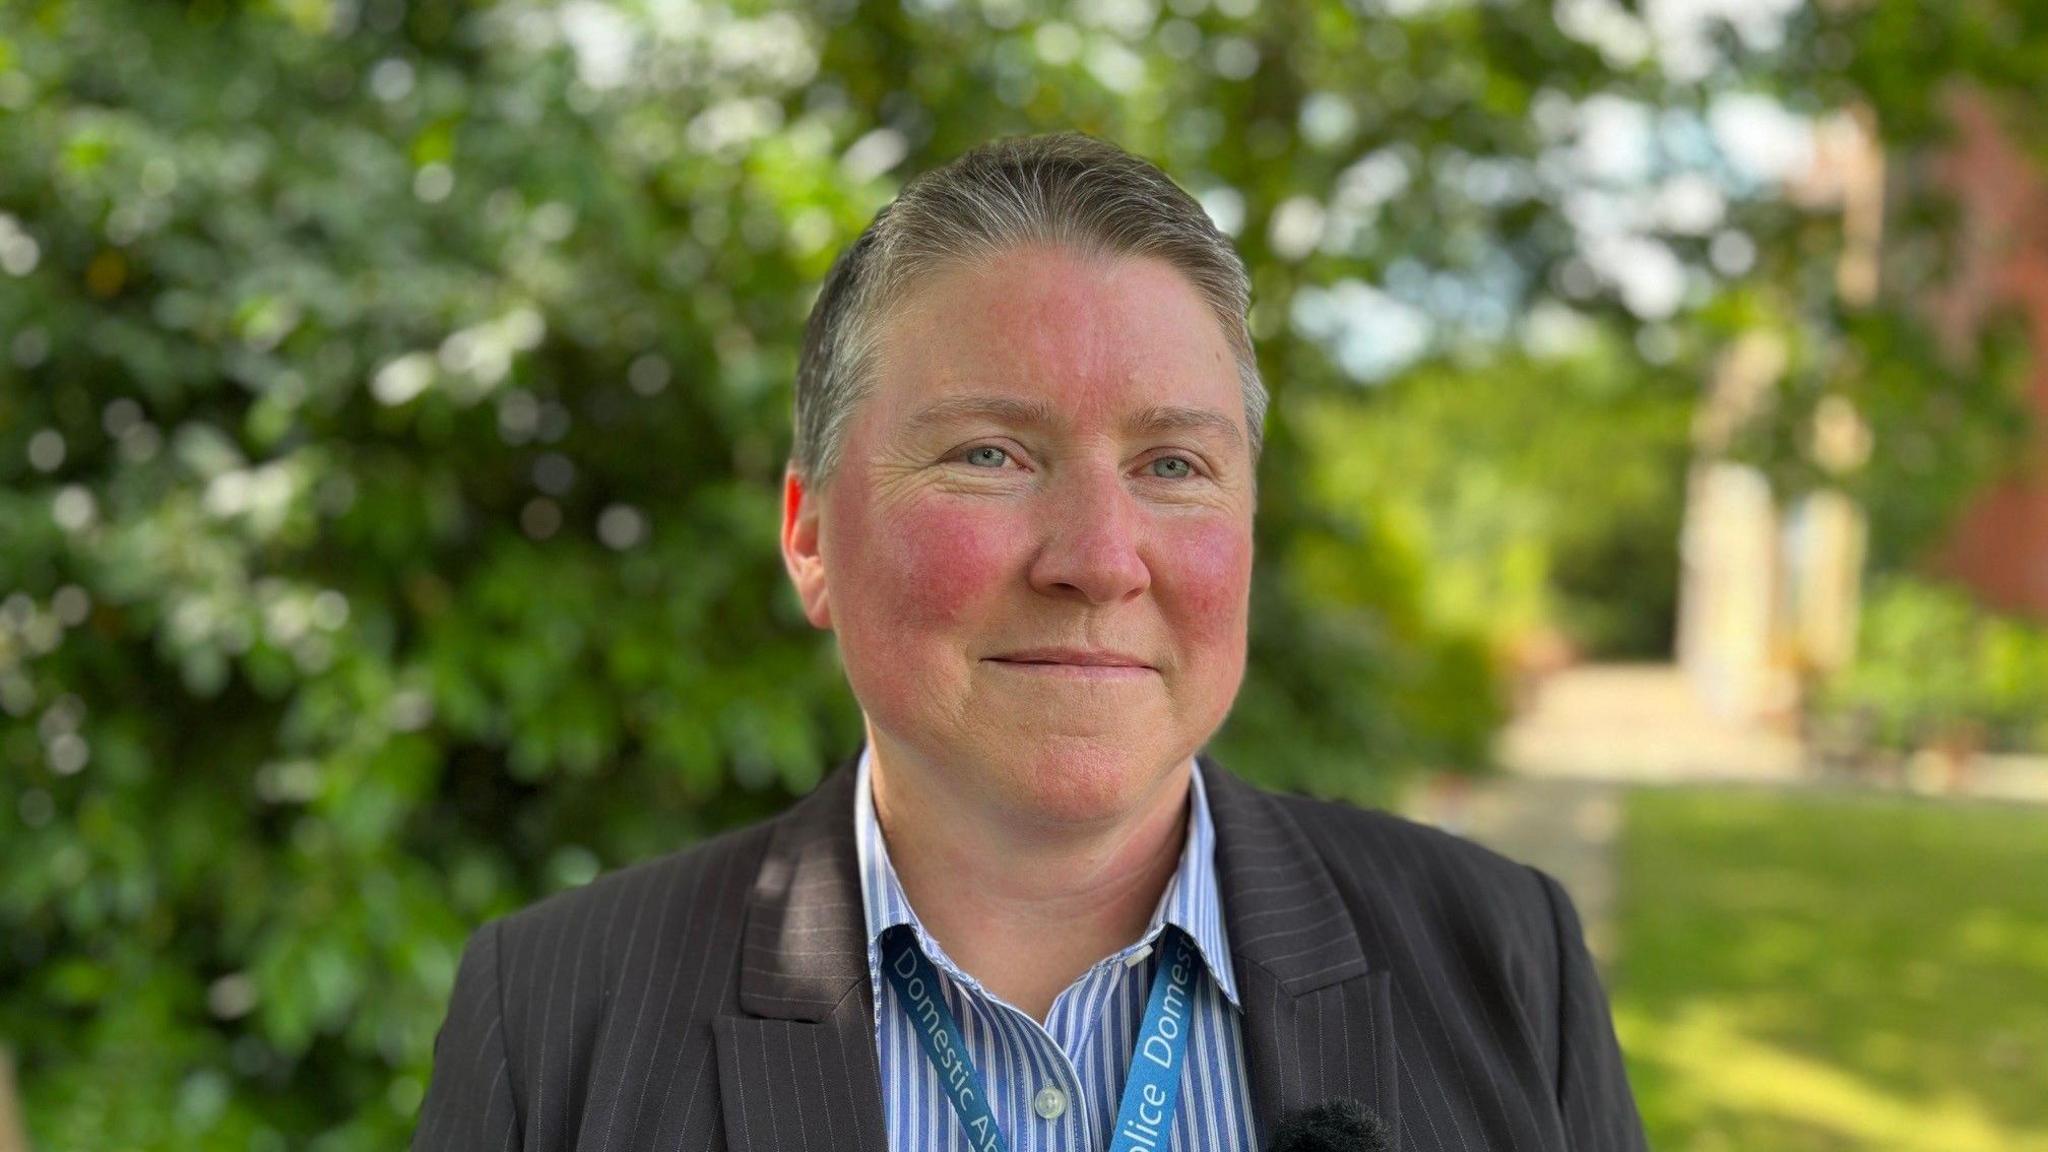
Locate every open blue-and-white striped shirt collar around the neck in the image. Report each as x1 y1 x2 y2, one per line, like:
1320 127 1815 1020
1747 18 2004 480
854 746 1243 1011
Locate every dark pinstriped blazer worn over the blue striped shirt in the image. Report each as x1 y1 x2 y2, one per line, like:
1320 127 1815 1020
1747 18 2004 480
414 756 1645 1152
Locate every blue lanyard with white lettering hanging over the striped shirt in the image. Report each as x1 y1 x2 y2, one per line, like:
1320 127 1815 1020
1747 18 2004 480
883 924 1194 1152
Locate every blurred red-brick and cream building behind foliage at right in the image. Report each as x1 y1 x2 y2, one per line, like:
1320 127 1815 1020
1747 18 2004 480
1677 90 2048 724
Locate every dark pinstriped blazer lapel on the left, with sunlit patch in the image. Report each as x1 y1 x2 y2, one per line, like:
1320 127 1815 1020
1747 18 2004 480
713 752 887 1152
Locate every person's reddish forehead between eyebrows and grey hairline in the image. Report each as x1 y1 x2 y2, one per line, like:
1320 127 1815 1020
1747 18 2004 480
870 246 1245 441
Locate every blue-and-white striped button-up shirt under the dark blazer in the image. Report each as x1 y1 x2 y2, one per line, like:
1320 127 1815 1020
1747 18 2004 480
854 748 1255 1152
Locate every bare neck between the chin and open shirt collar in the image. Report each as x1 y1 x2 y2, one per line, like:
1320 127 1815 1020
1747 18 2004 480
868 740 1190 1021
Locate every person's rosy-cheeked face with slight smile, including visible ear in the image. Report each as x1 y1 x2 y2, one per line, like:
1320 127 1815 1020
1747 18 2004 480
784 246 1253 818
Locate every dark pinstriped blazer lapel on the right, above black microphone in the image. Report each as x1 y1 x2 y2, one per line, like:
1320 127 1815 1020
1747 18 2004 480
1198 756 1401 1148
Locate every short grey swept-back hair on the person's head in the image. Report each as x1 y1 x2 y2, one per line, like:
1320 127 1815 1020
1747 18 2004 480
791 131 1266 486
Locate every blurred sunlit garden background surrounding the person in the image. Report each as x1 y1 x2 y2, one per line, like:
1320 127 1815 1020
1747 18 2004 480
0 0 2048 1152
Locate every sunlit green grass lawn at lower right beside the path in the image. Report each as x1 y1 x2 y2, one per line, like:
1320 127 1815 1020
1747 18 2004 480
1608 789 2048 1152
